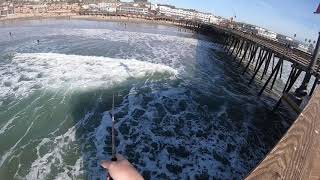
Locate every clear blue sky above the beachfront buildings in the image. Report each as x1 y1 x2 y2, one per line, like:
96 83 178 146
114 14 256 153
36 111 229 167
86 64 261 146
146 0 320 40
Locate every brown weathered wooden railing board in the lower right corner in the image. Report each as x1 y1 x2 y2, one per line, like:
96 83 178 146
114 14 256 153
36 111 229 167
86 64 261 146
246 87 320 180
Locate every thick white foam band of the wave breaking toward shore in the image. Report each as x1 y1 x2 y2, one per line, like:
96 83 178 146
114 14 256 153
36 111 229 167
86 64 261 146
0 53 177 100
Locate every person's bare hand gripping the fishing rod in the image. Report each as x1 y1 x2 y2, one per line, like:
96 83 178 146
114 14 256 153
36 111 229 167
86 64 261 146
101 154 143 180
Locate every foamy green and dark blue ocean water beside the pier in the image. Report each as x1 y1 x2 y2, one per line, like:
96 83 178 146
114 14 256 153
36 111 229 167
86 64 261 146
0 19 294 179
